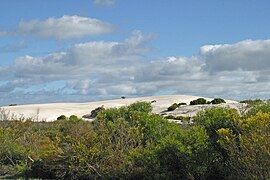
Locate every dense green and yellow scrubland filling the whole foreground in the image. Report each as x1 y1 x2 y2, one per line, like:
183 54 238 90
0 101 270 179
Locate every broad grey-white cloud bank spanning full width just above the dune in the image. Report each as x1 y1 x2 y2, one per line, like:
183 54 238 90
0 36 270 103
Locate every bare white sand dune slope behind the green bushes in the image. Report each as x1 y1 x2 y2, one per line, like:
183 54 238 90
2 95 236 121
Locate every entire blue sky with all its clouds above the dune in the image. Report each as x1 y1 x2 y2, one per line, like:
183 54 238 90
0 0 270 105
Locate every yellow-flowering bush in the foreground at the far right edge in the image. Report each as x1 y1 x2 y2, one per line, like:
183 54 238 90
217 112 270 179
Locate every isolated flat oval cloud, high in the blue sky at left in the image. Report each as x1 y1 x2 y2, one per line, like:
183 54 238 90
8 15 113 40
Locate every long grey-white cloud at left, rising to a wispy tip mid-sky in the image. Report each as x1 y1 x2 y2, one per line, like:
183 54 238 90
9 32 148 79
